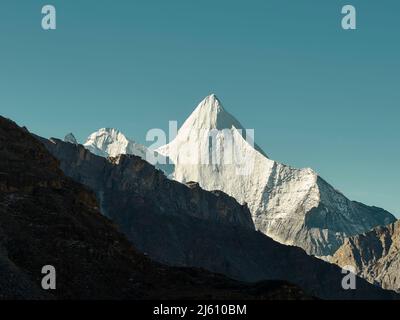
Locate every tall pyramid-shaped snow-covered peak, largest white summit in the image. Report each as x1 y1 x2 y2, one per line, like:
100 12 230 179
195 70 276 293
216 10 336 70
157 95 395 256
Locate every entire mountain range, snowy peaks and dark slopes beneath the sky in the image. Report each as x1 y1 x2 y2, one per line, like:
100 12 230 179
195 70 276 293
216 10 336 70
0 95 399 299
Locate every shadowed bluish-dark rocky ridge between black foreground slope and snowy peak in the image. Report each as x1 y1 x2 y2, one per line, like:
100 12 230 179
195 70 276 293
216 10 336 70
41 134 398 299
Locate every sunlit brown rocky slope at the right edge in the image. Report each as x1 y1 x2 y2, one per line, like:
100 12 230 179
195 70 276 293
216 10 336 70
332 221 400 292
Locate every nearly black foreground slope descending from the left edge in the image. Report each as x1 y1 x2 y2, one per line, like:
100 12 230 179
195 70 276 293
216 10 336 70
0 117 305 299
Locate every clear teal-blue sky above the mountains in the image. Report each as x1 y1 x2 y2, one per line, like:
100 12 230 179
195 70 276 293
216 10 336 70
0 0 400 216
